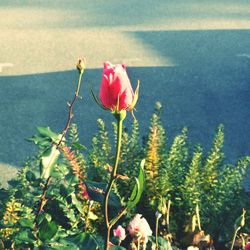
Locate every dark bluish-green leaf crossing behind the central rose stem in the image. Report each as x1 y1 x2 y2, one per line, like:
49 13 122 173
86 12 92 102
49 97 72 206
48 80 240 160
84 180 121 207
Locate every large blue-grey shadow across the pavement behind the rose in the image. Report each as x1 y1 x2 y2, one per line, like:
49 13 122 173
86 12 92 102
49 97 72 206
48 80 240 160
0 30 250 172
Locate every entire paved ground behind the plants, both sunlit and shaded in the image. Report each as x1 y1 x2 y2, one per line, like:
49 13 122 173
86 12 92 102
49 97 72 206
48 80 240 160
0 0 250 188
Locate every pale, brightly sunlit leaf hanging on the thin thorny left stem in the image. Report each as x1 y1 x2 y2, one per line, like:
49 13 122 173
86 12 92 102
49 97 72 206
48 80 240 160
40 145 60 179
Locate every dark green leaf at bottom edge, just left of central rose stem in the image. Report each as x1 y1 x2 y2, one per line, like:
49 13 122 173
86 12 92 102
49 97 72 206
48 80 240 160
66 233 99 250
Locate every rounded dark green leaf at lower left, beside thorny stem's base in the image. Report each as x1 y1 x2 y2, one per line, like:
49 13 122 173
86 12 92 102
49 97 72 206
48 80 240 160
38 218 58 241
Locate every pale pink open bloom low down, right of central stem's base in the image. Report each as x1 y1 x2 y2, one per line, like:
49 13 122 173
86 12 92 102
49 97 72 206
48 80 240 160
128 214 152 241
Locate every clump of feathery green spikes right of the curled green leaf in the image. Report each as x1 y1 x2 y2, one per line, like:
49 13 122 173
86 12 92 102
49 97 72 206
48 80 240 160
140 104 249 244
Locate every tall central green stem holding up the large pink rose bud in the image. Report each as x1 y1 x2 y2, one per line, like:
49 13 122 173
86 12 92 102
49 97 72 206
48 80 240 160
104 114 126 250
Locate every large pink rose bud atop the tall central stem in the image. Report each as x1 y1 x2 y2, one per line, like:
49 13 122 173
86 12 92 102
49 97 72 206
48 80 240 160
99 62 134 111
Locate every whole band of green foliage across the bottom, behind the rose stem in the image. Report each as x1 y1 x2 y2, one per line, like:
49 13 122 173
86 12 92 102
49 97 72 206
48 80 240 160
0 100 250 249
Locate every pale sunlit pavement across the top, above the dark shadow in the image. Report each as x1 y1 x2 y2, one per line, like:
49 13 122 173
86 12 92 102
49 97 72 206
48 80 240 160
0 0 250 76
